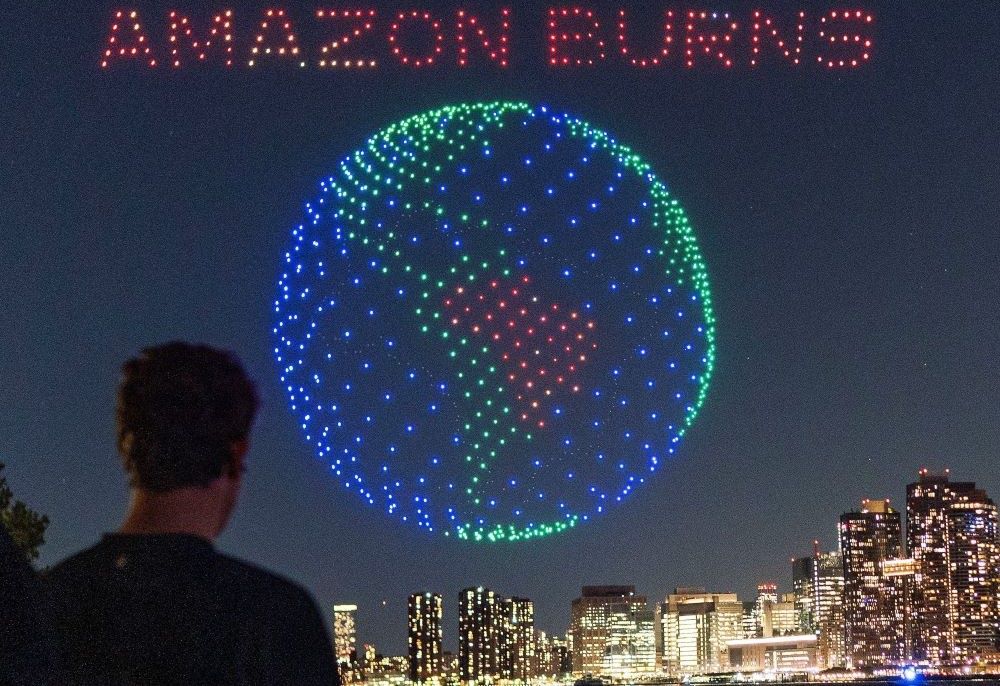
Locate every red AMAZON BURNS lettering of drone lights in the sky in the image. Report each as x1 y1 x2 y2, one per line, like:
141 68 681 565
100 5 875 71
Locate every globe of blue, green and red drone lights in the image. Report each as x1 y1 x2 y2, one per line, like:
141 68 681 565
272 102 715 541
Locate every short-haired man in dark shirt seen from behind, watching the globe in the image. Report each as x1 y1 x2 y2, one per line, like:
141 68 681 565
47 343 339 686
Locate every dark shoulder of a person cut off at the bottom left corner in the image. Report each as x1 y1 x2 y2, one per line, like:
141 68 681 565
0 524 60 686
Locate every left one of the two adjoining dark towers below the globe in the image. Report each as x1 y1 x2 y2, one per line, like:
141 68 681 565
458 586 504 683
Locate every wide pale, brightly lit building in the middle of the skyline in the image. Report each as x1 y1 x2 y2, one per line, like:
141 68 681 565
660 588 743 677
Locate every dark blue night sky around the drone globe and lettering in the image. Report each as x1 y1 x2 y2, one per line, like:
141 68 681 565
0 0 1000 653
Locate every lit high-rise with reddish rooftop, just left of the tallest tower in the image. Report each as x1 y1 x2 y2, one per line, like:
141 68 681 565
839 500 914 669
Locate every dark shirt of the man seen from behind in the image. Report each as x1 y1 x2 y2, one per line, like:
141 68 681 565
46 534 339 686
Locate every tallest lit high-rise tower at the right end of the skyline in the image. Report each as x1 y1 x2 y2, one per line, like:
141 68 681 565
906 469 1000 663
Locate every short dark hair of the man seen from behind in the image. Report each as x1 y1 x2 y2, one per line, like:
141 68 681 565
116 341 259 492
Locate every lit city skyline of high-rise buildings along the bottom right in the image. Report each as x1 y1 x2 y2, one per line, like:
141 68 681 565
330 468 1000 668
